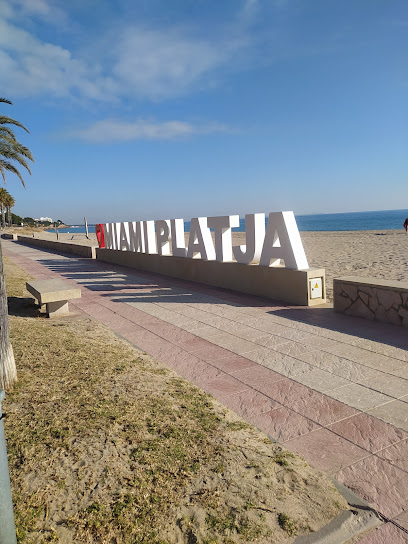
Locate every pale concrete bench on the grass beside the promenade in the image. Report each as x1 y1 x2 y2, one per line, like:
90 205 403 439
26 280 81 317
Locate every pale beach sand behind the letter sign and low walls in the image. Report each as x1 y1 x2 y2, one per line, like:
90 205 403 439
26 229 408 301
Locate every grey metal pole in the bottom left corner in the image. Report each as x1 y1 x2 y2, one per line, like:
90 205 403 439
0 391 17 544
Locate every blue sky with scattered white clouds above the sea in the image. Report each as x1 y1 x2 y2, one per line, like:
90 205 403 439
0 0 408 224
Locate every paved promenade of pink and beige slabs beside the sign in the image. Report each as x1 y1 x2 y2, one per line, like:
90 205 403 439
2 241 408 544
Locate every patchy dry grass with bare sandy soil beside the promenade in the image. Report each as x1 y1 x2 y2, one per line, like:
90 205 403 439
5 261 346 544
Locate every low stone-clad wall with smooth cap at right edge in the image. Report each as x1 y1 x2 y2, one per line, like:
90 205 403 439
333 276 408 327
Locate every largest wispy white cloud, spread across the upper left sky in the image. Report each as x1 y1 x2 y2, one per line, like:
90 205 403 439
0 0 250 101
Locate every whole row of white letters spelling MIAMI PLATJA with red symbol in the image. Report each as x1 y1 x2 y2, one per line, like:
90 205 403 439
97 212 309 270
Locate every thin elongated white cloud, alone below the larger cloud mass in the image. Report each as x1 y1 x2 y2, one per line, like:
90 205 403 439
69 119 228 143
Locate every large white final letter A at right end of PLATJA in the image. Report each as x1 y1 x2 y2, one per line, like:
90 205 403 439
259 212 309 270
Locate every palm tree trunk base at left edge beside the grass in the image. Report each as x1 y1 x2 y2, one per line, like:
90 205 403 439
0 242 17 391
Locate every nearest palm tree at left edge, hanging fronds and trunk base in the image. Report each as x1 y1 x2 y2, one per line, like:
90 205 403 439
0 98 34 390
